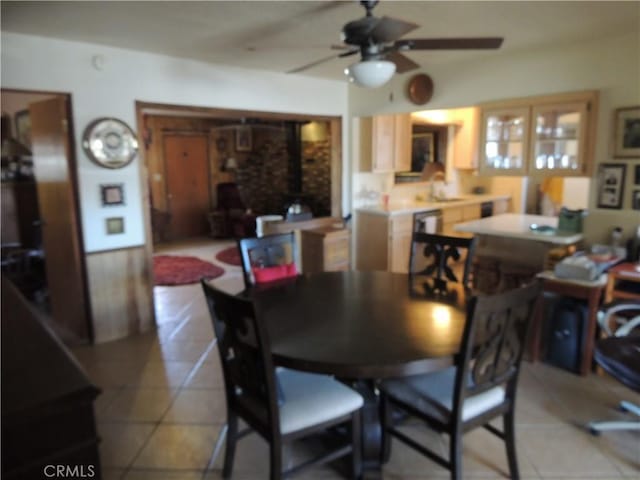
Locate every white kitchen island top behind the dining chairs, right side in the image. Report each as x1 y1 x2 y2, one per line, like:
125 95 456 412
453 213 582 245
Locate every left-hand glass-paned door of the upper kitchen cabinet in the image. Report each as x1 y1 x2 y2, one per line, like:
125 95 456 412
480 108 529 175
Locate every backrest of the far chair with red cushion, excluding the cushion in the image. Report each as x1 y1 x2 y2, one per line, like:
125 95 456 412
238 232 298 288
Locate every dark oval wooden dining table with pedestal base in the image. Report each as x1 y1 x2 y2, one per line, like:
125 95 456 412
244 271 468 478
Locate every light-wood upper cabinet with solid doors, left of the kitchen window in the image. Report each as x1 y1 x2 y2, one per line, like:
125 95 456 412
354 113 411 173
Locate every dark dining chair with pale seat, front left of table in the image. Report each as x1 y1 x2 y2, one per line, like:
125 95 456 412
201 280 363 480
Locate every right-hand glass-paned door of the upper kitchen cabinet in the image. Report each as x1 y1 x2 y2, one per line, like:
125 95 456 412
530 103 587 173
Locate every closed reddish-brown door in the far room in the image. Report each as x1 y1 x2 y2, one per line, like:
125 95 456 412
164 135 210 239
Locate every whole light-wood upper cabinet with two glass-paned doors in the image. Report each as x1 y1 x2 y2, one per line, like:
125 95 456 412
479 91 598 176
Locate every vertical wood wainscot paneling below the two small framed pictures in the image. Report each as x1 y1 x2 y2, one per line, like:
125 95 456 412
87 247 154 343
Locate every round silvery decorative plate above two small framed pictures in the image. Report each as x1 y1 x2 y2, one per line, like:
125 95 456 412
82 117 138 168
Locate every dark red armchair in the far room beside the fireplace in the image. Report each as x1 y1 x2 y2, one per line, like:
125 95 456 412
209 182 256 238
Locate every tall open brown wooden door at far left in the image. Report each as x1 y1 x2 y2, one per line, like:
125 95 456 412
29 96 92 341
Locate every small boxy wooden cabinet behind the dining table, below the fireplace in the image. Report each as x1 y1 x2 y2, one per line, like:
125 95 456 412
300 227 351 273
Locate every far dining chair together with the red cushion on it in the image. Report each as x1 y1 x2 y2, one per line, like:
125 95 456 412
238 232 298 288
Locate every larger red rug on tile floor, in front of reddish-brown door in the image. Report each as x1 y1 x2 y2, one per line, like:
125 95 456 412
153 255 224 285
